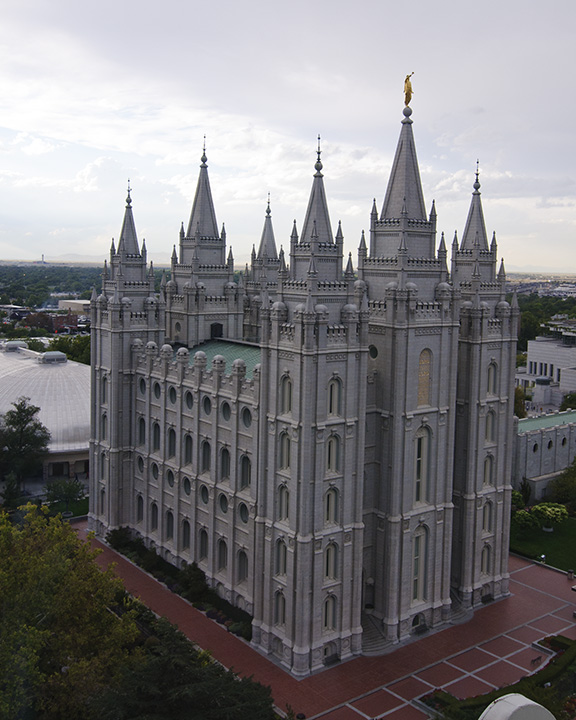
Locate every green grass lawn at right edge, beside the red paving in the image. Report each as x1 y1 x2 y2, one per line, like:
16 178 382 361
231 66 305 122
510 518 576 570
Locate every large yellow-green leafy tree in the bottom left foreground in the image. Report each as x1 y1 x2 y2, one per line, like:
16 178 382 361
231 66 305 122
0 505 139 720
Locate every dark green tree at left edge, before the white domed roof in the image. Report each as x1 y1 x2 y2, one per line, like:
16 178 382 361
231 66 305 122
0 397 50 483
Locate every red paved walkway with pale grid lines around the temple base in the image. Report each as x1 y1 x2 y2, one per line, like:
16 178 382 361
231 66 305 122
75 523 576 720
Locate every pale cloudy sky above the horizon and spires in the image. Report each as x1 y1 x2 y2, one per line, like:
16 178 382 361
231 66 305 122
0 0 576 273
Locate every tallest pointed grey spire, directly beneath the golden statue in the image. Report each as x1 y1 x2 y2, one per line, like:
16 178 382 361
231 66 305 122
380 107 426 220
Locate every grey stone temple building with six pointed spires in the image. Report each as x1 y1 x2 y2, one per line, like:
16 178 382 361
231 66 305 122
90 107 518 677
